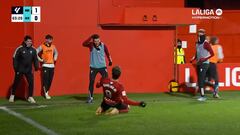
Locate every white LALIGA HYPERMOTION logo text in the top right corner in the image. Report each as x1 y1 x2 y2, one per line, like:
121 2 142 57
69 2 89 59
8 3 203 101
192 8 223 19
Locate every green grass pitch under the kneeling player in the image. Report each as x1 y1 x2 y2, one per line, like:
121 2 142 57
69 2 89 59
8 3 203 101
0 91 240 135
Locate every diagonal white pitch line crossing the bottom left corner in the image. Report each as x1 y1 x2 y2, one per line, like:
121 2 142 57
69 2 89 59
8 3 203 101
0 106 58 135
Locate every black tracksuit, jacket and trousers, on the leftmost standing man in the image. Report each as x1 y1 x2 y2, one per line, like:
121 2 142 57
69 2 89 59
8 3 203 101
11 43 39 97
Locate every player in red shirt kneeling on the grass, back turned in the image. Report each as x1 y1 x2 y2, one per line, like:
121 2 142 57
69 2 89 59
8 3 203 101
96 66 146 115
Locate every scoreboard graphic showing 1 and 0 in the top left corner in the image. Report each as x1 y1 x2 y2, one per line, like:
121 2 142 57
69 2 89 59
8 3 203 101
11 6 41 22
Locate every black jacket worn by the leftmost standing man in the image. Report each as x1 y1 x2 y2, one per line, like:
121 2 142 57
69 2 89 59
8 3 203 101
13 44 39 73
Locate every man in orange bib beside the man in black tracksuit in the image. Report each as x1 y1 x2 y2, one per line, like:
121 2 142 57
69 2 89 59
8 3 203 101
37 34 58 99
